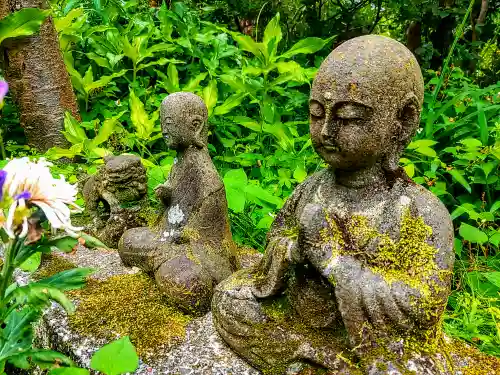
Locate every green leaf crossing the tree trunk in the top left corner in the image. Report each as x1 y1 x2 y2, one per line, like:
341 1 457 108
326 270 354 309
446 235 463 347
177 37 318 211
0 8 50 44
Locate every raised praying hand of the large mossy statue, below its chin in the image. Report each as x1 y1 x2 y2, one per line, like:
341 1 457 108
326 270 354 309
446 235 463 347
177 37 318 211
299 203 344 277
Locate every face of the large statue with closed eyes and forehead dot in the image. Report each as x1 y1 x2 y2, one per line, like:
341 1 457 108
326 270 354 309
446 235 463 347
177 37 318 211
309 91 396 169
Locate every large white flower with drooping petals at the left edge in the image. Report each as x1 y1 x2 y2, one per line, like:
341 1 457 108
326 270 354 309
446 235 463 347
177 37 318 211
3 157 82 237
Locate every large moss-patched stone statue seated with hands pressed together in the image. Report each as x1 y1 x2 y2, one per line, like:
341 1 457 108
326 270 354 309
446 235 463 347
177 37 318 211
212 35 454 374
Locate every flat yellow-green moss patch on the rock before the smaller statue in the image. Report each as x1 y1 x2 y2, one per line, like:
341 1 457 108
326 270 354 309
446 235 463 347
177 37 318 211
70 274 192 358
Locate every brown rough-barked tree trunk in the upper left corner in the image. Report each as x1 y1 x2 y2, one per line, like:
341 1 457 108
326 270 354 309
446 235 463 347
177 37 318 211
0 0 79 152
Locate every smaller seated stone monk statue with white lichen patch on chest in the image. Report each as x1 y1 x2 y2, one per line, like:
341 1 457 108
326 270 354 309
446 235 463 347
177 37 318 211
118 92 237 313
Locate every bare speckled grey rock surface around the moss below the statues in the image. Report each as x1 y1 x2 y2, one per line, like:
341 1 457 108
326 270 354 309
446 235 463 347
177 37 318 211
28 246 259 375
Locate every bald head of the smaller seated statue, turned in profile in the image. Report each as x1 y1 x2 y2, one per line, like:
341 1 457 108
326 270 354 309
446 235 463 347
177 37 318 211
160 92 208 150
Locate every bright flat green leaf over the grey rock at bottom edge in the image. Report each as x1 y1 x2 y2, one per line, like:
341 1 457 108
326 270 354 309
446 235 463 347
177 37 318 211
90 336 139 375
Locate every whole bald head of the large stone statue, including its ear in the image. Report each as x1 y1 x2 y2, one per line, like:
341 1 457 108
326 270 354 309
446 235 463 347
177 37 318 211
309 35 424 171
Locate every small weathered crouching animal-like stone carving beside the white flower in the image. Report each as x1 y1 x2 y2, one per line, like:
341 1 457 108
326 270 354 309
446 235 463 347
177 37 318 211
83 155 147 247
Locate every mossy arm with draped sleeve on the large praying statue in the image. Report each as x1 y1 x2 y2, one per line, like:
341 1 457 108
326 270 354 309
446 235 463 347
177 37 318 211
301 201 453 341
